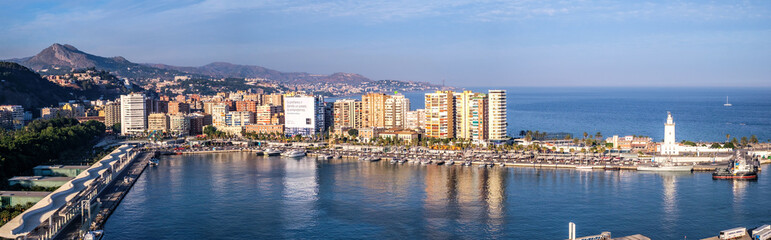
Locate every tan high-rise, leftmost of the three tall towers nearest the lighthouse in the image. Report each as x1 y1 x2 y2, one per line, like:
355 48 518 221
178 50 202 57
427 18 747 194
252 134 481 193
424 91 455 138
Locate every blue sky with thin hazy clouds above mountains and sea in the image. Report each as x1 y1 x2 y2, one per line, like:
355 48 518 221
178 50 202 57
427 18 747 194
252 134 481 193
0 0 771 86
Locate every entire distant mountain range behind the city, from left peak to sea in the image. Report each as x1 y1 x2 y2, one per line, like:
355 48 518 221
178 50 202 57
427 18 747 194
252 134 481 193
7 43 446 94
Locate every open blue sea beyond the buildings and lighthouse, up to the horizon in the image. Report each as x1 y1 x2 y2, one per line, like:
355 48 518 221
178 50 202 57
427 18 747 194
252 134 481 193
328 87 771 141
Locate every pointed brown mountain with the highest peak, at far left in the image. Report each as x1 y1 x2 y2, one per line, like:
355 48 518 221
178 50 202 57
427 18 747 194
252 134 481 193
8 43 192 80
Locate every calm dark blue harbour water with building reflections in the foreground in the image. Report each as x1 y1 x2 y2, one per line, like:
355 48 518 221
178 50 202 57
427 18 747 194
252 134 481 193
105 153 771 240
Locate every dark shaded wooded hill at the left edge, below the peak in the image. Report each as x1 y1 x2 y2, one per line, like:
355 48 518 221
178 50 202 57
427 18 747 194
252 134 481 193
0 62 76 110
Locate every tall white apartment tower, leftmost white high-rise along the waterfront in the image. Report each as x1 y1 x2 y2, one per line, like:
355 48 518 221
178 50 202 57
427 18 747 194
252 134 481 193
120 93 147 135
